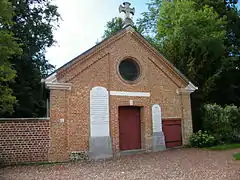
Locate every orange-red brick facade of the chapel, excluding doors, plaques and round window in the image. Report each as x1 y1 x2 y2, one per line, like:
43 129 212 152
46 28 197 161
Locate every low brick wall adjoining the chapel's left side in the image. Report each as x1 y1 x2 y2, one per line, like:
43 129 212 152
0 118 50 165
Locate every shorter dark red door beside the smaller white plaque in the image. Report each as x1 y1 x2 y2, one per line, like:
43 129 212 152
163 119 182 148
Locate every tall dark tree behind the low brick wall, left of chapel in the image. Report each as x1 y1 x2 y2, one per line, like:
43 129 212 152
4 0 60 117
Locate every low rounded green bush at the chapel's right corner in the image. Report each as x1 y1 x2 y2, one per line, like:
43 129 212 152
189 130 217 148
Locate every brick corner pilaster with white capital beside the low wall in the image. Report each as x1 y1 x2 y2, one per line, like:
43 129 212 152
42 73 72 162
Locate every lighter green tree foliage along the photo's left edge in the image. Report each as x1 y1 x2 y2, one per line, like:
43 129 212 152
0 0 21 114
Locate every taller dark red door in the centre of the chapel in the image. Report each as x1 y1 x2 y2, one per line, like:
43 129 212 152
119 106 141 150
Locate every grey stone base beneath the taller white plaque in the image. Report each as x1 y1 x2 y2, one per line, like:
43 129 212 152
88 136 113 160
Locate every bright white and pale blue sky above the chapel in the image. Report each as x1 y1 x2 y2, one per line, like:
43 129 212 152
46 0 149 68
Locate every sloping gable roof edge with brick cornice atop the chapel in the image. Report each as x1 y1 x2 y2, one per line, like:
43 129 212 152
43 25 198 90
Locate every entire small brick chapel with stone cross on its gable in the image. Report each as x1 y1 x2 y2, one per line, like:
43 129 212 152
44 3 197 161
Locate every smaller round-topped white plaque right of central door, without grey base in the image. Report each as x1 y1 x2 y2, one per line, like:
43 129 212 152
152 104 162 132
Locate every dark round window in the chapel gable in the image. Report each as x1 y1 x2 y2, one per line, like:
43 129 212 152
118 59 140 81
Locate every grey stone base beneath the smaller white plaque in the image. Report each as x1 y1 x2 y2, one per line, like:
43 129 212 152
152 132 166 152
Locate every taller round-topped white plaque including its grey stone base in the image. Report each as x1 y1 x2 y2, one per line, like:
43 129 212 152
88 86 113 160
